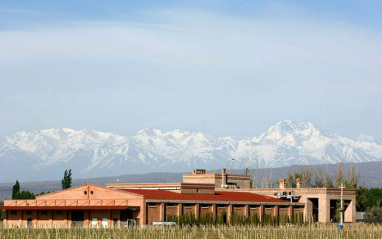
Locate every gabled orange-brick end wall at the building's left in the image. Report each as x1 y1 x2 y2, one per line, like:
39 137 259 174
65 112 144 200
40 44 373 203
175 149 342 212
4 184 146 227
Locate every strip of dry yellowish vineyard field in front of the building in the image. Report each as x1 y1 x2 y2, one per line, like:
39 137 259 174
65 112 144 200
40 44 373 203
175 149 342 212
0 223 382 239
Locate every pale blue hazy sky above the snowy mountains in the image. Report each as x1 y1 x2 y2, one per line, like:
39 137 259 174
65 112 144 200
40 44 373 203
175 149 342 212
0 0 382 139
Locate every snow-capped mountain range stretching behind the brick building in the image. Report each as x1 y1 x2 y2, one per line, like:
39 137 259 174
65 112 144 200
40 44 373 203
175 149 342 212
0 120 382 182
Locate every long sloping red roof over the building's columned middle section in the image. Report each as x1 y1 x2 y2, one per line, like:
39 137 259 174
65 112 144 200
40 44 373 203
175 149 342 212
120 189 289 203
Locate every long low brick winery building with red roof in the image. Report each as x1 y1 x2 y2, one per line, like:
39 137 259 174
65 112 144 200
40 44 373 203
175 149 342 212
0 169 355 227
